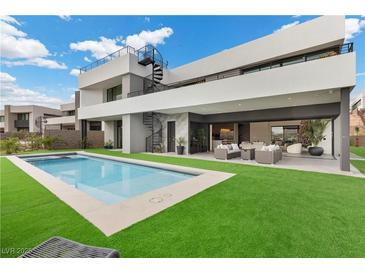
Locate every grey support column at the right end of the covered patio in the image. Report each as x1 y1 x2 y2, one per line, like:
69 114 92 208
340 88 350 171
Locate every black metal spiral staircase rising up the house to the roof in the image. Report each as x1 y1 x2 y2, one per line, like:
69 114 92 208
137 45 167 152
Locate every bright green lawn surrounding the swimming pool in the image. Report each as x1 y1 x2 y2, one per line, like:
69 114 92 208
1 149 365 257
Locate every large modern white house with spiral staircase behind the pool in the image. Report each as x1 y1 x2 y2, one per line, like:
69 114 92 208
78 16 356 170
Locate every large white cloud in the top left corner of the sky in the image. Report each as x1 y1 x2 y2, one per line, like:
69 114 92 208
0 16 66 69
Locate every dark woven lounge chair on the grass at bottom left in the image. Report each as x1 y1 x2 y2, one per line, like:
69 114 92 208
20 236 119 258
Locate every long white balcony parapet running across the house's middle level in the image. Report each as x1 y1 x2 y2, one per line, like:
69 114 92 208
78 51 356 119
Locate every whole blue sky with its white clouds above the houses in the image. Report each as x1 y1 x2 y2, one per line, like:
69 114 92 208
0 16 365 108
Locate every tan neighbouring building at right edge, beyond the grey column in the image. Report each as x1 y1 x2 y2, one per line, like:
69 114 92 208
350 92 365 136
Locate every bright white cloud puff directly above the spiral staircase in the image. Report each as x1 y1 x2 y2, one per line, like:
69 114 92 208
125 27 174 49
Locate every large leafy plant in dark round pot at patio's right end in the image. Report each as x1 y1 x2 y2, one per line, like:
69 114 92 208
305 120 329 156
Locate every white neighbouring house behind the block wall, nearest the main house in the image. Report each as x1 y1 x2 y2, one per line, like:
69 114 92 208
45 92 102 131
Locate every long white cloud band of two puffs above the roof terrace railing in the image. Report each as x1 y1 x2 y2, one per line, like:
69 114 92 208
70 27 174 59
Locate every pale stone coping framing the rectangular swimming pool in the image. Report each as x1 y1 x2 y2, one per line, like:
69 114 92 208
7 151 235 236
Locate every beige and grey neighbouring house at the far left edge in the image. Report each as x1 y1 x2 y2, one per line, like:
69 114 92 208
0 105 62 133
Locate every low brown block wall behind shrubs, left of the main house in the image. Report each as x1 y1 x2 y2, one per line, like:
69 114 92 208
44 130 104 149
